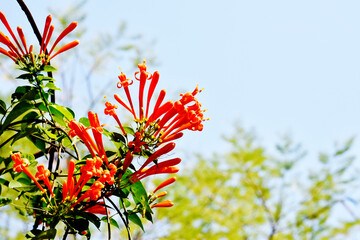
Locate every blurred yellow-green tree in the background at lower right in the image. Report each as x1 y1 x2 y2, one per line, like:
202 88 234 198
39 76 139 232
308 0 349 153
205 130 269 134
150 128 360 239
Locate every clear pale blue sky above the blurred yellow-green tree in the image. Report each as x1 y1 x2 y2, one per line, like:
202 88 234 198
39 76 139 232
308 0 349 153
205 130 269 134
1 0 360 161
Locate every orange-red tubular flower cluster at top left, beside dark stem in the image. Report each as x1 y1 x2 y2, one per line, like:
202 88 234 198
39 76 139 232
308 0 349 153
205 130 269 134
0 12 79 66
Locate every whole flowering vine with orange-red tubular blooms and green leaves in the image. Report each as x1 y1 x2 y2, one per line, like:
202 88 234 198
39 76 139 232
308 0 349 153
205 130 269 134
0 8 207 239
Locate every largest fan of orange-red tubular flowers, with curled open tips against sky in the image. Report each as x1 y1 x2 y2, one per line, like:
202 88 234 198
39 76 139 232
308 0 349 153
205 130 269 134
105 61 206 146
